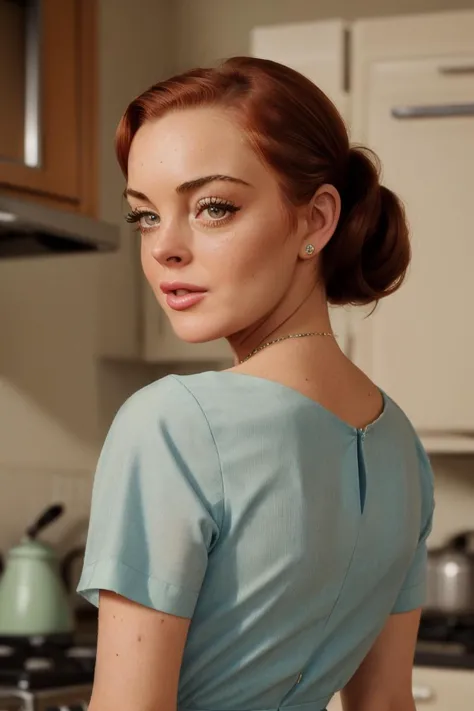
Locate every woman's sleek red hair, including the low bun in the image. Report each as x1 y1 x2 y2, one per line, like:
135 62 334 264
115 57 410 304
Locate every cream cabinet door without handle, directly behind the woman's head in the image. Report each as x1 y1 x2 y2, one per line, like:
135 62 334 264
251 19 350 351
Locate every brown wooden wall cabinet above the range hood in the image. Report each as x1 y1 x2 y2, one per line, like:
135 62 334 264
0 0 97 214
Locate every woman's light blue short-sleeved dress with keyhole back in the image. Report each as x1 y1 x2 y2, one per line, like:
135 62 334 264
79 372 433 711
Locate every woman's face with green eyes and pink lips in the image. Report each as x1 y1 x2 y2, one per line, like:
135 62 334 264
127 108 314 343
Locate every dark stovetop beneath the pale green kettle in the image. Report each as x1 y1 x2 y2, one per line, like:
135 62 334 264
0 637 96 711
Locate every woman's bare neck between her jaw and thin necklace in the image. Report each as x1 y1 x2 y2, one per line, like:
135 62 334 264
228 287 332 363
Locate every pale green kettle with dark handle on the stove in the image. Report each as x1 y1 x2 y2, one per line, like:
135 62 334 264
0 504 74 637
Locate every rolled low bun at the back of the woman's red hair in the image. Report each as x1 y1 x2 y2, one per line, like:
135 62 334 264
323 148 410 304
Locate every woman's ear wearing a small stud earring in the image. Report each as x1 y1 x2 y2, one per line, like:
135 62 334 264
299 184 341 259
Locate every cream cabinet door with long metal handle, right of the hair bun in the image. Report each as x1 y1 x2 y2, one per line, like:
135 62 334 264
355 55 474 433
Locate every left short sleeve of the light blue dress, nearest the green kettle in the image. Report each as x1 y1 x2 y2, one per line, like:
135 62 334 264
78 376 223 618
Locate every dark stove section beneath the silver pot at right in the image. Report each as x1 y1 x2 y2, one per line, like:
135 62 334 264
415 614 474 670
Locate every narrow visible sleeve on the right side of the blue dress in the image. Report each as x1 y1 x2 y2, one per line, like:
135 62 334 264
392 437 435 613
